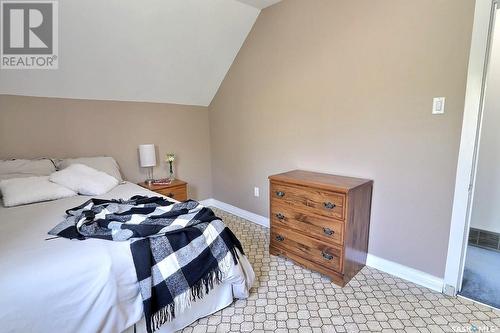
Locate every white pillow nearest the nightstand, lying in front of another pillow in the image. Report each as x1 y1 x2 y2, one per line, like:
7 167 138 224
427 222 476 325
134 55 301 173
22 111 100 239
49 164 118 195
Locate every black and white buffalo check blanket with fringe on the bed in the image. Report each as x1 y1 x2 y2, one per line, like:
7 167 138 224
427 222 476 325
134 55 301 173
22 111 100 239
49 196 244 332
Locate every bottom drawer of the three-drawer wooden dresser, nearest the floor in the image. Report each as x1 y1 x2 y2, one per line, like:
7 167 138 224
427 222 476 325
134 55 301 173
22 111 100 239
271 225 342 272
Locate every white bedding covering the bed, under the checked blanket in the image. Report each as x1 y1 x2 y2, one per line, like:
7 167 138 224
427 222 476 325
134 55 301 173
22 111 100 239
0 183 255 333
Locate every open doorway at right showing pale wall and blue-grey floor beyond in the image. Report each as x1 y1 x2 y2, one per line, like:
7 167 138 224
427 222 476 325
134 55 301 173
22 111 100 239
458 7 500 309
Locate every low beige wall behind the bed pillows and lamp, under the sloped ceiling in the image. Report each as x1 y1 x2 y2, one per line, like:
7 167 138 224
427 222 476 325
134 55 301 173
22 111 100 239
0 95 211 199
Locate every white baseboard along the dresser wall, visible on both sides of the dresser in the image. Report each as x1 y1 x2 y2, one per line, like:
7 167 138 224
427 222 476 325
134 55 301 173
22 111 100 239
200 198 444 292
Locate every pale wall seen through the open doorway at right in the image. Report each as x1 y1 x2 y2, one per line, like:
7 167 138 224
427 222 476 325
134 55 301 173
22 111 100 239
471 13 500 233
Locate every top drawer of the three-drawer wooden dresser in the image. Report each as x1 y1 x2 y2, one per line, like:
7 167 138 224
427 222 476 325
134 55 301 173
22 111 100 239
270 183 345 220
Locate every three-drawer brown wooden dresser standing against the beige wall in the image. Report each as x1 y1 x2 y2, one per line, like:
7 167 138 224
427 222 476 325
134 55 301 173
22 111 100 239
269 170 373 286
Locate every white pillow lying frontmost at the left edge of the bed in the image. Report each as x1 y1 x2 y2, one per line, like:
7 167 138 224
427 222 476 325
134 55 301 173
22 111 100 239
0 176 76 207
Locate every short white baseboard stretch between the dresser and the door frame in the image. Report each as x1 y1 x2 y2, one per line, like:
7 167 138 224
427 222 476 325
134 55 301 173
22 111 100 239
366 253 444 292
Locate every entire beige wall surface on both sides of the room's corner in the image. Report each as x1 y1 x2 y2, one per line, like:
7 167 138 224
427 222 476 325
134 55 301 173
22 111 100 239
0 0 474 276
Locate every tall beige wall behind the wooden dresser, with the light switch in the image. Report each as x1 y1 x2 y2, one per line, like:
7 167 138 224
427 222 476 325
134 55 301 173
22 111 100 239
210 0 474 276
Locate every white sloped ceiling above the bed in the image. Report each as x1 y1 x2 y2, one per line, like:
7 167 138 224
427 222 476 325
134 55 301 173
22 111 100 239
0 0 266 106
